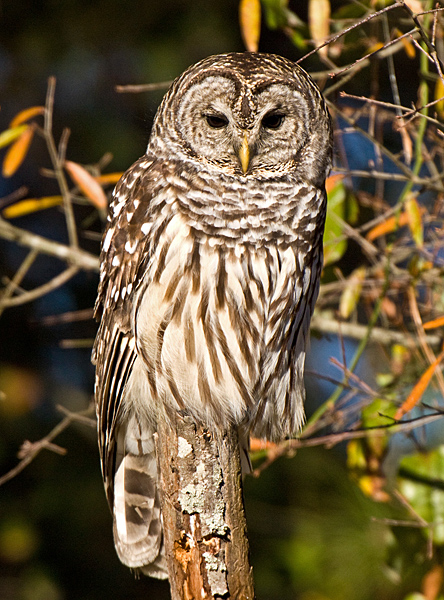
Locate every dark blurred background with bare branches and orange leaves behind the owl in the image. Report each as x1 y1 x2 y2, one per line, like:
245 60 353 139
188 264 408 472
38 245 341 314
0 0 444 600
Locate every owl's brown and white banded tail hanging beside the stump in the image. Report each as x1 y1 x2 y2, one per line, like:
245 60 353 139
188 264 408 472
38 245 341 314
113 427 168 579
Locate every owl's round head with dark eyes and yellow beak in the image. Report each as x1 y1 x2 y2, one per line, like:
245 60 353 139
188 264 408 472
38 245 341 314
148 52 332 185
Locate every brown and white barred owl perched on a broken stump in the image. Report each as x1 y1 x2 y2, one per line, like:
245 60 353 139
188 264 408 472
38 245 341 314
93 53 332 578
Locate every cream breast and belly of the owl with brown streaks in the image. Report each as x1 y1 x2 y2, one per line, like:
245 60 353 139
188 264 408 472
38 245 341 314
114 158 324 439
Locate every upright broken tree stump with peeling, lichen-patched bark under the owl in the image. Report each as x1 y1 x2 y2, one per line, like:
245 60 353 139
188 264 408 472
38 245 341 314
157 415 254 600
